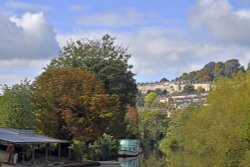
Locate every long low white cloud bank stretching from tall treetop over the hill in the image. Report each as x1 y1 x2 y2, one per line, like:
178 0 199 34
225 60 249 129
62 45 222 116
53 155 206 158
57 27 250 81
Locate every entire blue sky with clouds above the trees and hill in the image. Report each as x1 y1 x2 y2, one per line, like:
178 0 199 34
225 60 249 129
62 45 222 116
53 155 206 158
0 0 250 85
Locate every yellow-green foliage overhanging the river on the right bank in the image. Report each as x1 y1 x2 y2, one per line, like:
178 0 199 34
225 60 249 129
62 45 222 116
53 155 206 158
161 72 250 166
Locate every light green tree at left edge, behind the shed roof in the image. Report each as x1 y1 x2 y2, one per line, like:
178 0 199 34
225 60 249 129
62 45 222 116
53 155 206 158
0 80 35 129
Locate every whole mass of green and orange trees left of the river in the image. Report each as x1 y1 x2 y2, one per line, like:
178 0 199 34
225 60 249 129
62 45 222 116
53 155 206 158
0 35 138 159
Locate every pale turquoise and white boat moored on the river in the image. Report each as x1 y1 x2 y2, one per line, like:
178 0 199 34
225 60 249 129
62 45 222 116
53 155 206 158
118 139 142 157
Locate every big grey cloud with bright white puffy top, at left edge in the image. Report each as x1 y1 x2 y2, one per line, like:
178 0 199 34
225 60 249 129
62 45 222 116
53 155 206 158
0 13 59 85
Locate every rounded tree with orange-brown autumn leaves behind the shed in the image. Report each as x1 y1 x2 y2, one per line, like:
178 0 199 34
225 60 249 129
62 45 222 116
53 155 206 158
32 68 119 141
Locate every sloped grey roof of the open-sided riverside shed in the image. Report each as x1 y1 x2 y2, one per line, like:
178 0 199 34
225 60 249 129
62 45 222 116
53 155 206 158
0 128 69 144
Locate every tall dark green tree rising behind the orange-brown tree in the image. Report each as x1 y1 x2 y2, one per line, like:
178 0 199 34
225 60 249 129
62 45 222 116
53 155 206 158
47 35 137 136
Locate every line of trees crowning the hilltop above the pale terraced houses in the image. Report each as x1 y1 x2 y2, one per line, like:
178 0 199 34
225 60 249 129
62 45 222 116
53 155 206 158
175 59 245 82
